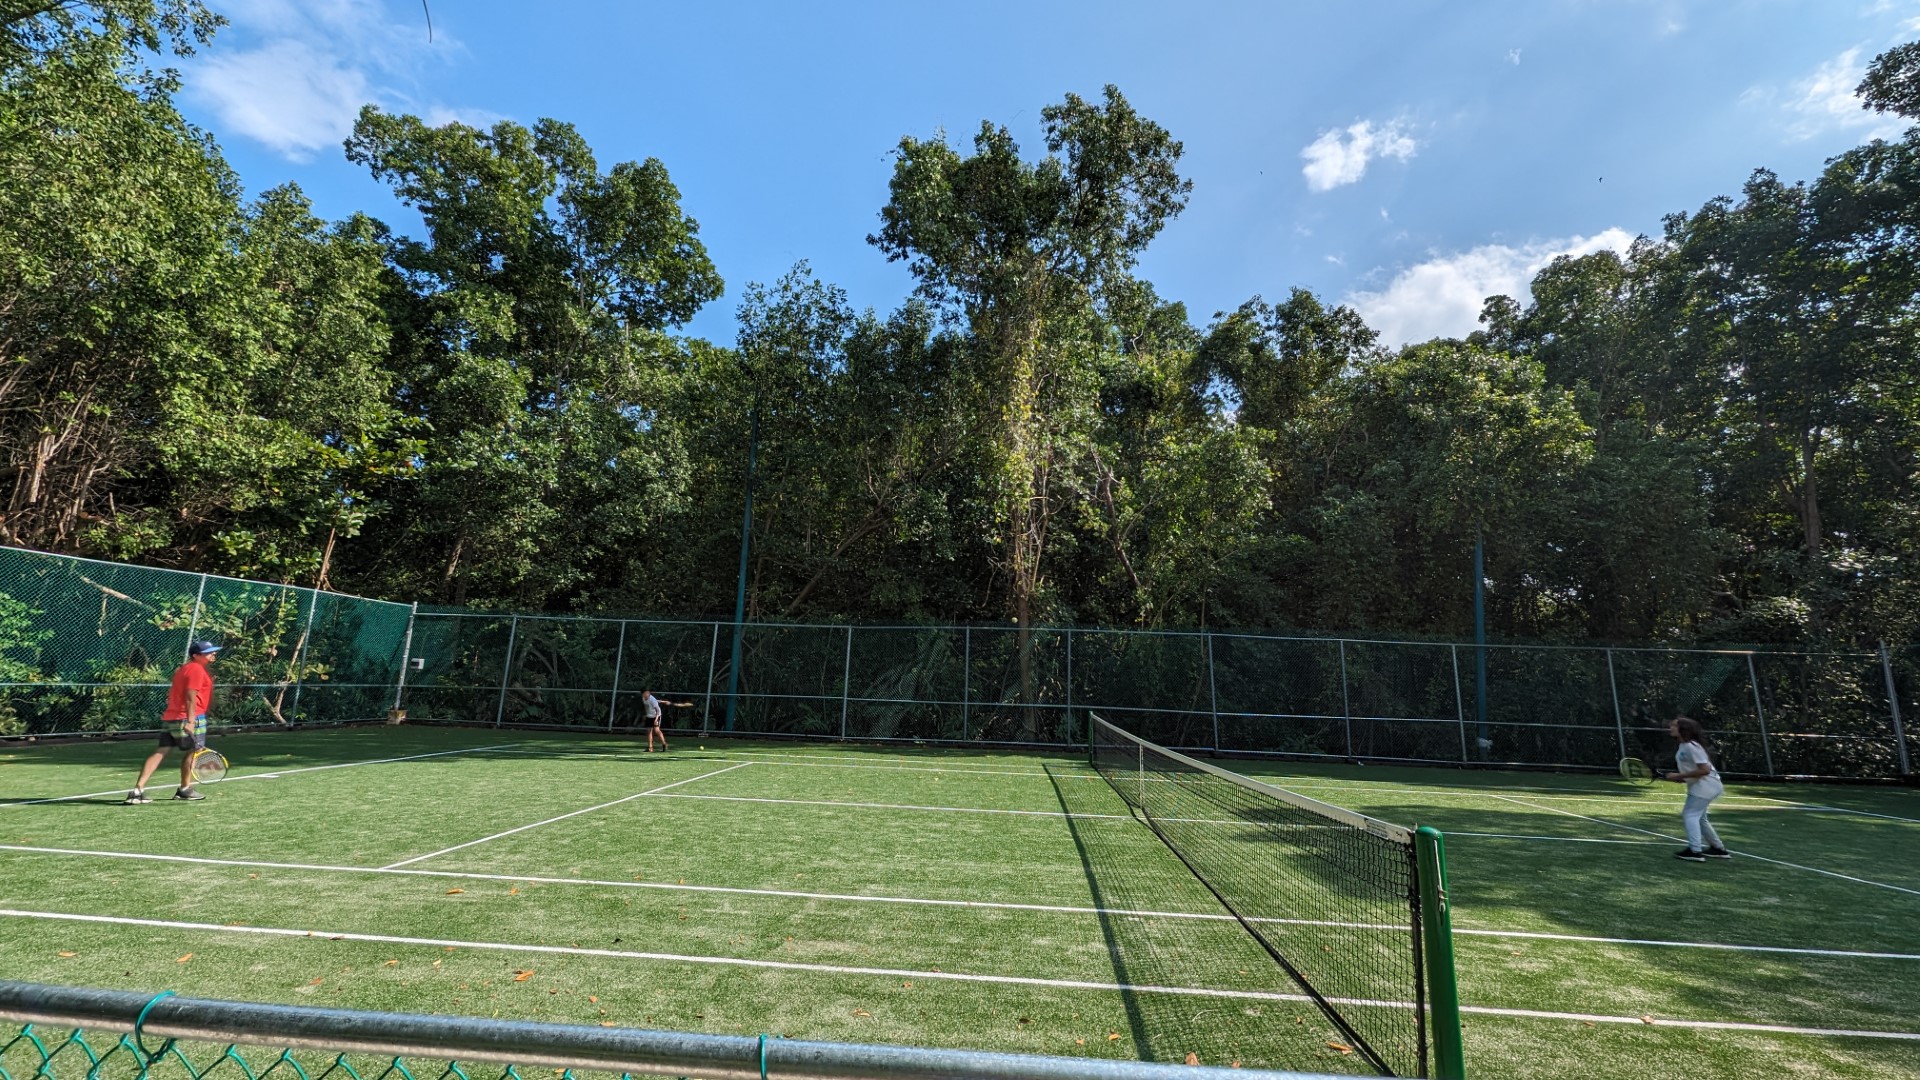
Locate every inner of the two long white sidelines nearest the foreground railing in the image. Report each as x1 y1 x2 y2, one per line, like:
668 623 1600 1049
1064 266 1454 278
0 840 1920 961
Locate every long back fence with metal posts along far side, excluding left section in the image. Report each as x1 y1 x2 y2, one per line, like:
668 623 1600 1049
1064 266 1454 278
407 611 1920 776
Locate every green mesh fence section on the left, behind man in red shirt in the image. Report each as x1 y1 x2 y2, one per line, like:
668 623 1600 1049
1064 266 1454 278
0 548 413 736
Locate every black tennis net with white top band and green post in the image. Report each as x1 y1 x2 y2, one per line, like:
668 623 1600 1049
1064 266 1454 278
1091 717 1459 1076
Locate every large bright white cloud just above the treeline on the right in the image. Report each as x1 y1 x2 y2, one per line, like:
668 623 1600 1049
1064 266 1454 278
1346 227 1634 346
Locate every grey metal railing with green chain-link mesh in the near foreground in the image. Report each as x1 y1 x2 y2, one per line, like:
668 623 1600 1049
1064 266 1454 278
0 982 1336 1080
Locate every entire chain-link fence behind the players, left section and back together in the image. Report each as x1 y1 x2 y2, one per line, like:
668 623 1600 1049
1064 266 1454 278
0 548 1920 778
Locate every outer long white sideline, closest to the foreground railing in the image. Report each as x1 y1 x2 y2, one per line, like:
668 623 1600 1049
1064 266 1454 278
0 909 1920 1042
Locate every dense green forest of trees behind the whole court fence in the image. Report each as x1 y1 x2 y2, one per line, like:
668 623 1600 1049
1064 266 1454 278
0 0 1920 644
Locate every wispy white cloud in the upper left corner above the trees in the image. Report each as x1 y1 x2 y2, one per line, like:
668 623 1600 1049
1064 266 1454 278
186 0 487 161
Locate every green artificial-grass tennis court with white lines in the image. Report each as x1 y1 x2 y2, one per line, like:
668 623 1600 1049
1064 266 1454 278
0 714 1920 1080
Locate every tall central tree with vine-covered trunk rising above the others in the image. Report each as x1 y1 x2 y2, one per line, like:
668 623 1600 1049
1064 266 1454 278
868 86 1190 714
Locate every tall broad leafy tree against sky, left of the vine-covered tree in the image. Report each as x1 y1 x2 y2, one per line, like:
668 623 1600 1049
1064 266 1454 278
348 106 722 605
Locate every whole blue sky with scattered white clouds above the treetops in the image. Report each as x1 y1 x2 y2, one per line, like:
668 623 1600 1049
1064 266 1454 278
180 0 1920 344
